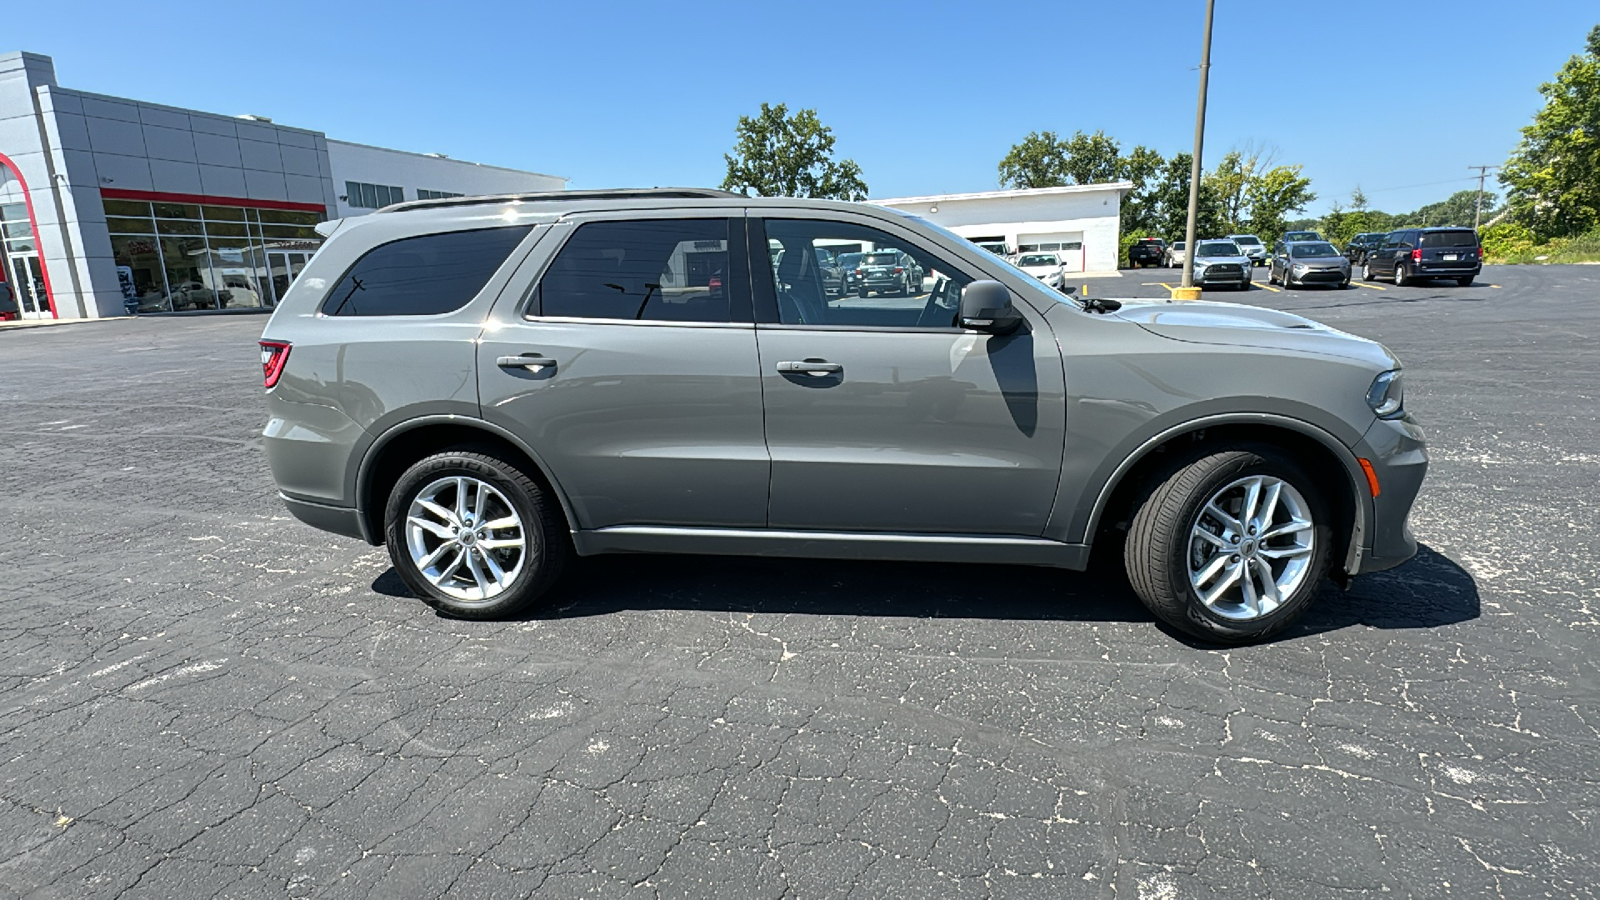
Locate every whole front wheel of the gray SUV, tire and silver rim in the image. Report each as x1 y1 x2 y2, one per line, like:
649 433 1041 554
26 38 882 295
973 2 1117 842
1123 447 1333 644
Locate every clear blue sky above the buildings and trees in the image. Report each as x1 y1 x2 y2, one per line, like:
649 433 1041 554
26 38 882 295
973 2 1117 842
12 0 1600 213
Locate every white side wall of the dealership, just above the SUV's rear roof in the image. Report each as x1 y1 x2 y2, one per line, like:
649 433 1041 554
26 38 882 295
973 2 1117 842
328 141 566 218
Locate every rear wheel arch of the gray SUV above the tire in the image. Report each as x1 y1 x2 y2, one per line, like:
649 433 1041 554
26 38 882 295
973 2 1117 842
355 415 578 546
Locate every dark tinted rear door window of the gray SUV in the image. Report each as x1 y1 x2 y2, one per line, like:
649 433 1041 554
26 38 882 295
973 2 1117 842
534 219 736 322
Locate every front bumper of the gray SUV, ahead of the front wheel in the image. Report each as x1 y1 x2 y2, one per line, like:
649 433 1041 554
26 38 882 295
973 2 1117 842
1350 415 1427 575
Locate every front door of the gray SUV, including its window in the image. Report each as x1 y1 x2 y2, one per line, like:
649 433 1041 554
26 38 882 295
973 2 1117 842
750 215 1066 536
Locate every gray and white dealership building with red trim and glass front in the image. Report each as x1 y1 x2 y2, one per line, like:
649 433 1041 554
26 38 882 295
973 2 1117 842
0 53 566 319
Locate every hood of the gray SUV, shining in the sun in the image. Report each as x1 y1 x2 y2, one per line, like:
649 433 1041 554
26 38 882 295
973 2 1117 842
1112 301 1400 372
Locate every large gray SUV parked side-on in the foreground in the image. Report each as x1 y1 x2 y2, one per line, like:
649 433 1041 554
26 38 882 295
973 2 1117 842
261 189 1427 642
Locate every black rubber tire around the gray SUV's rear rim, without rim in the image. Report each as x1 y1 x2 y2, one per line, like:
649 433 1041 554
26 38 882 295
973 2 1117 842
384 447 571 618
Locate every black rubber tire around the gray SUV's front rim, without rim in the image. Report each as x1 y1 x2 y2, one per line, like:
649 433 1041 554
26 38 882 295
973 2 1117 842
1123 447 1333 644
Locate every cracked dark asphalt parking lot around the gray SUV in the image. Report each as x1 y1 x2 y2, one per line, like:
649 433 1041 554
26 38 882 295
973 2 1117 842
0 266 1600 900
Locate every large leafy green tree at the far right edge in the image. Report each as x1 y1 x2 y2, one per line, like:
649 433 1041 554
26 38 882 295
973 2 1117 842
1499 26 1600 239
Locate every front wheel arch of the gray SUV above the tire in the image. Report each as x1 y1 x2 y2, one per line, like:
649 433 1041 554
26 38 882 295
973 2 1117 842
1083 413 1373 572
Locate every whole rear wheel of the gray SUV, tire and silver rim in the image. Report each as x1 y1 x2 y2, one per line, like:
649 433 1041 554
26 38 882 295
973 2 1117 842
384 448 568 618
